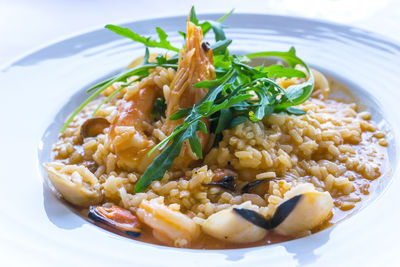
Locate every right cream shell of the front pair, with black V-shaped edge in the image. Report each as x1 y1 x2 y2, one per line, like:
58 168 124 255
233 191 333 236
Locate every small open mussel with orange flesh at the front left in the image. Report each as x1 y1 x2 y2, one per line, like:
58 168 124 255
88 206 141 237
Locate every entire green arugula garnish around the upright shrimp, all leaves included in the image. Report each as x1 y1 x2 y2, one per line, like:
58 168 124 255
61 8 314 192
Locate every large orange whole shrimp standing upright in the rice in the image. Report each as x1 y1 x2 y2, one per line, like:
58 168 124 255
109 21 215 173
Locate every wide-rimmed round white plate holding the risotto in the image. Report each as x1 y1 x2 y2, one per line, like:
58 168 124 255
0 14 400 267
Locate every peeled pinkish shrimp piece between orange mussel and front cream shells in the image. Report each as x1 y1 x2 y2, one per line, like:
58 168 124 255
136 197 200 247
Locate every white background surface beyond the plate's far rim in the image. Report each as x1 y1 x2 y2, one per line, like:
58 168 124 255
0 0 400 66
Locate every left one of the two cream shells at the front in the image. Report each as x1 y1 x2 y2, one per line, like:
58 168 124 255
202 203 268 243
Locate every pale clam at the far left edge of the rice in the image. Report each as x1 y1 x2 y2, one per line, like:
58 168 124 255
43 162 103 207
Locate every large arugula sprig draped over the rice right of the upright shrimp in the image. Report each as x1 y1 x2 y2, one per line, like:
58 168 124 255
135 48 314 192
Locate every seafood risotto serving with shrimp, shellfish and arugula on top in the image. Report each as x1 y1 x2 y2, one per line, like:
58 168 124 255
44 10 388 249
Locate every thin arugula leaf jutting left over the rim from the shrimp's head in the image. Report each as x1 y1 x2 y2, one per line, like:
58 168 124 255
105 24 179 52
